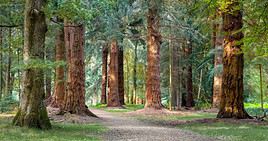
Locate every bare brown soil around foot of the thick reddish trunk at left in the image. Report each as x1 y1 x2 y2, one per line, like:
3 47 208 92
47 107 100 124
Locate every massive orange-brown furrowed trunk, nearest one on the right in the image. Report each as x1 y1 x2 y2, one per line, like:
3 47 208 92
217 0 250 119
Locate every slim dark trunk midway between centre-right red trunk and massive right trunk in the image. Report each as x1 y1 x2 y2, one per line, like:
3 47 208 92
186 39 194 107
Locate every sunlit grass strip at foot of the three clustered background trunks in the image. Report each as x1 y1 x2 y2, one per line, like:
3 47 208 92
92 104 144 113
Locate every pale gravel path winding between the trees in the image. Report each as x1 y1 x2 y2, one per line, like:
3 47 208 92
91 109 217 141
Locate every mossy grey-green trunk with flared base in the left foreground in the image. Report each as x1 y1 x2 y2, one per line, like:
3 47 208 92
13 0 51 129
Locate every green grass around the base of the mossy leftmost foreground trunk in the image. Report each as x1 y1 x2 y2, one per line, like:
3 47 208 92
0 114 106 141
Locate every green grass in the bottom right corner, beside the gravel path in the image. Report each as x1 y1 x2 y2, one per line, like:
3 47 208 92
178 122 268 141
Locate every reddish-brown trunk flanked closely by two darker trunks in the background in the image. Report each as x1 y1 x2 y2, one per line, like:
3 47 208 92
107 40 122 107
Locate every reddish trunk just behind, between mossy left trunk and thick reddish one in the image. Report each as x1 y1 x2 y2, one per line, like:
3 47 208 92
50 28 66 109
